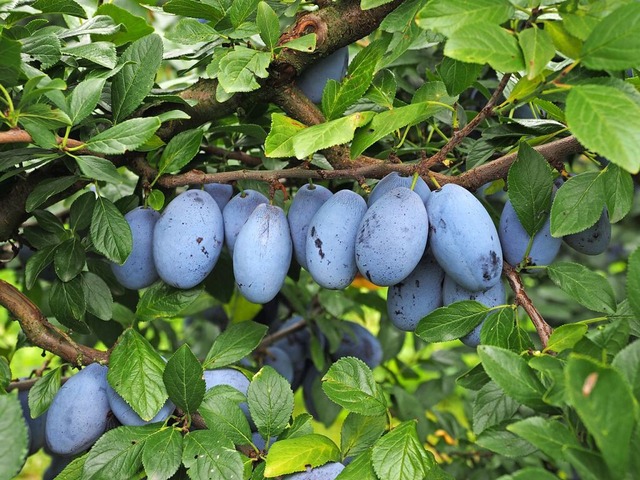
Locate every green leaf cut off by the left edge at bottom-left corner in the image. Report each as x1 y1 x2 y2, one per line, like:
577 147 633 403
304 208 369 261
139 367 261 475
0 395 28 478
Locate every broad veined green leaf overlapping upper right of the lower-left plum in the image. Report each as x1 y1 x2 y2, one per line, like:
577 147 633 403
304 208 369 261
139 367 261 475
107 329 168 421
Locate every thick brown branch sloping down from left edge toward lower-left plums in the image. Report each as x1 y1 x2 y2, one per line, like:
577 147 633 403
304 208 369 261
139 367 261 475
0 280 109 366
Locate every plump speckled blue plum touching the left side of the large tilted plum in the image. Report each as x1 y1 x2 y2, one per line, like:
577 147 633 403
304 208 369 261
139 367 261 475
355 187 429 286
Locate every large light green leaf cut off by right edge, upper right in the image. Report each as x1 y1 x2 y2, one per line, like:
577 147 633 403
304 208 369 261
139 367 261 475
565 85 640 173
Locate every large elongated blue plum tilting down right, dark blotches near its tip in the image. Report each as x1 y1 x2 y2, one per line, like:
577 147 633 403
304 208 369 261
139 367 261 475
427 183 502 291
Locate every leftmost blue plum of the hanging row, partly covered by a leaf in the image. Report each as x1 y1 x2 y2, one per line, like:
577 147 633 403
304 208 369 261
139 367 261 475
111 207 160 290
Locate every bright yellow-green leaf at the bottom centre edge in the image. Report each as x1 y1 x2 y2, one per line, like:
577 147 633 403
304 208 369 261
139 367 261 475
264 433 340 478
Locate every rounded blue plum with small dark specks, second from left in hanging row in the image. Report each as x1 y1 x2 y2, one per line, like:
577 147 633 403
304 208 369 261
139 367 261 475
153 190 224 288
